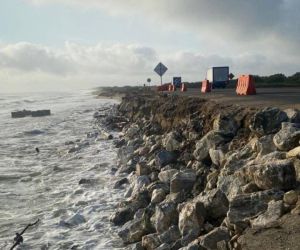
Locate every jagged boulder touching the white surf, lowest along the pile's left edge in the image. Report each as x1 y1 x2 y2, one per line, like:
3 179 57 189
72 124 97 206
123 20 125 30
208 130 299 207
118 212 152 244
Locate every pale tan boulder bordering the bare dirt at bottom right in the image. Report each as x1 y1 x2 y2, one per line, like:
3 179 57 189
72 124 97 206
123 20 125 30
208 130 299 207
251 200 284 228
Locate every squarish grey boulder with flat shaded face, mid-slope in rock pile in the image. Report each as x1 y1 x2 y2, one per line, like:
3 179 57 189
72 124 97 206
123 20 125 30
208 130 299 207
170 170 196 193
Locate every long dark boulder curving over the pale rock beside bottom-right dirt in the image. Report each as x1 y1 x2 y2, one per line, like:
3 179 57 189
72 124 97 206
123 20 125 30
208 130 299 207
226 190 284 228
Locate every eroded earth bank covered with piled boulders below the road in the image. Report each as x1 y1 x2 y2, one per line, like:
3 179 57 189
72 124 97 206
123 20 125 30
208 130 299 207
107 94 300 249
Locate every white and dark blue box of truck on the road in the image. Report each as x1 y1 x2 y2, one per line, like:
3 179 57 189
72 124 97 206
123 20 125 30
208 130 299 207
206 66 229 89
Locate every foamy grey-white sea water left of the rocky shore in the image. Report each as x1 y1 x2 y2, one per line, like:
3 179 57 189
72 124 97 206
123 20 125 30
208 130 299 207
0 91 123 250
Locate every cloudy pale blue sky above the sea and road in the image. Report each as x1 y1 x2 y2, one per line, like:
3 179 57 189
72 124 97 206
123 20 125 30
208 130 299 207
0 0 300 92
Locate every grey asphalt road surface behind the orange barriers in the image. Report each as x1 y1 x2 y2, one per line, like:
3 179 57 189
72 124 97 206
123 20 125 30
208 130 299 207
176 87 300 109
